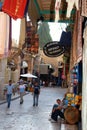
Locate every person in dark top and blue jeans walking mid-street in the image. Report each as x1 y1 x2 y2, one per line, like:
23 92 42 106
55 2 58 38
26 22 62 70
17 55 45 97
33 82 40 106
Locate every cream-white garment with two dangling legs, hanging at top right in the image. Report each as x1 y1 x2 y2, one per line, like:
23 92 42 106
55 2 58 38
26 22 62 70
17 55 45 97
66 0 79 18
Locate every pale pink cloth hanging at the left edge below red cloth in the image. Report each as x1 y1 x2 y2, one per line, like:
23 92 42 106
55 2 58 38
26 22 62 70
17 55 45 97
0 12 10 58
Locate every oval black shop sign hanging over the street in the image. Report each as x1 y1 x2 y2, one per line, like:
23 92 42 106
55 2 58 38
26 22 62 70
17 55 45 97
43 41 65 57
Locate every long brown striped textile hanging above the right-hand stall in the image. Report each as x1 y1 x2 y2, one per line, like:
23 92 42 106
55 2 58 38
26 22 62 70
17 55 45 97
70 11 82 69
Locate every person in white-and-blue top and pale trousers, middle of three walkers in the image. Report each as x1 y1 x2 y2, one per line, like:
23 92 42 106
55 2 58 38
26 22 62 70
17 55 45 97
18 80 25 104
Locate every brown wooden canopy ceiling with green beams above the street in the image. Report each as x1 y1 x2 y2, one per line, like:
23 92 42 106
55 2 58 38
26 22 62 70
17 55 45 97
28 0 75 24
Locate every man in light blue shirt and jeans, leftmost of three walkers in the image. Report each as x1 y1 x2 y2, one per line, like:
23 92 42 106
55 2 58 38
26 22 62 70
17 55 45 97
4 80 14 108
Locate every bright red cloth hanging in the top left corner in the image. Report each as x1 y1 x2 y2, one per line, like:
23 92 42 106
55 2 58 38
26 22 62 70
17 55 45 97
2 0 27 19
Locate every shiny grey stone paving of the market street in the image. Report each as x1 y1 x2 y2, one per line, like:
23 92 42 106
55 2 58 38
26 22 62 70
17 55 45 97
0 87 78 130
